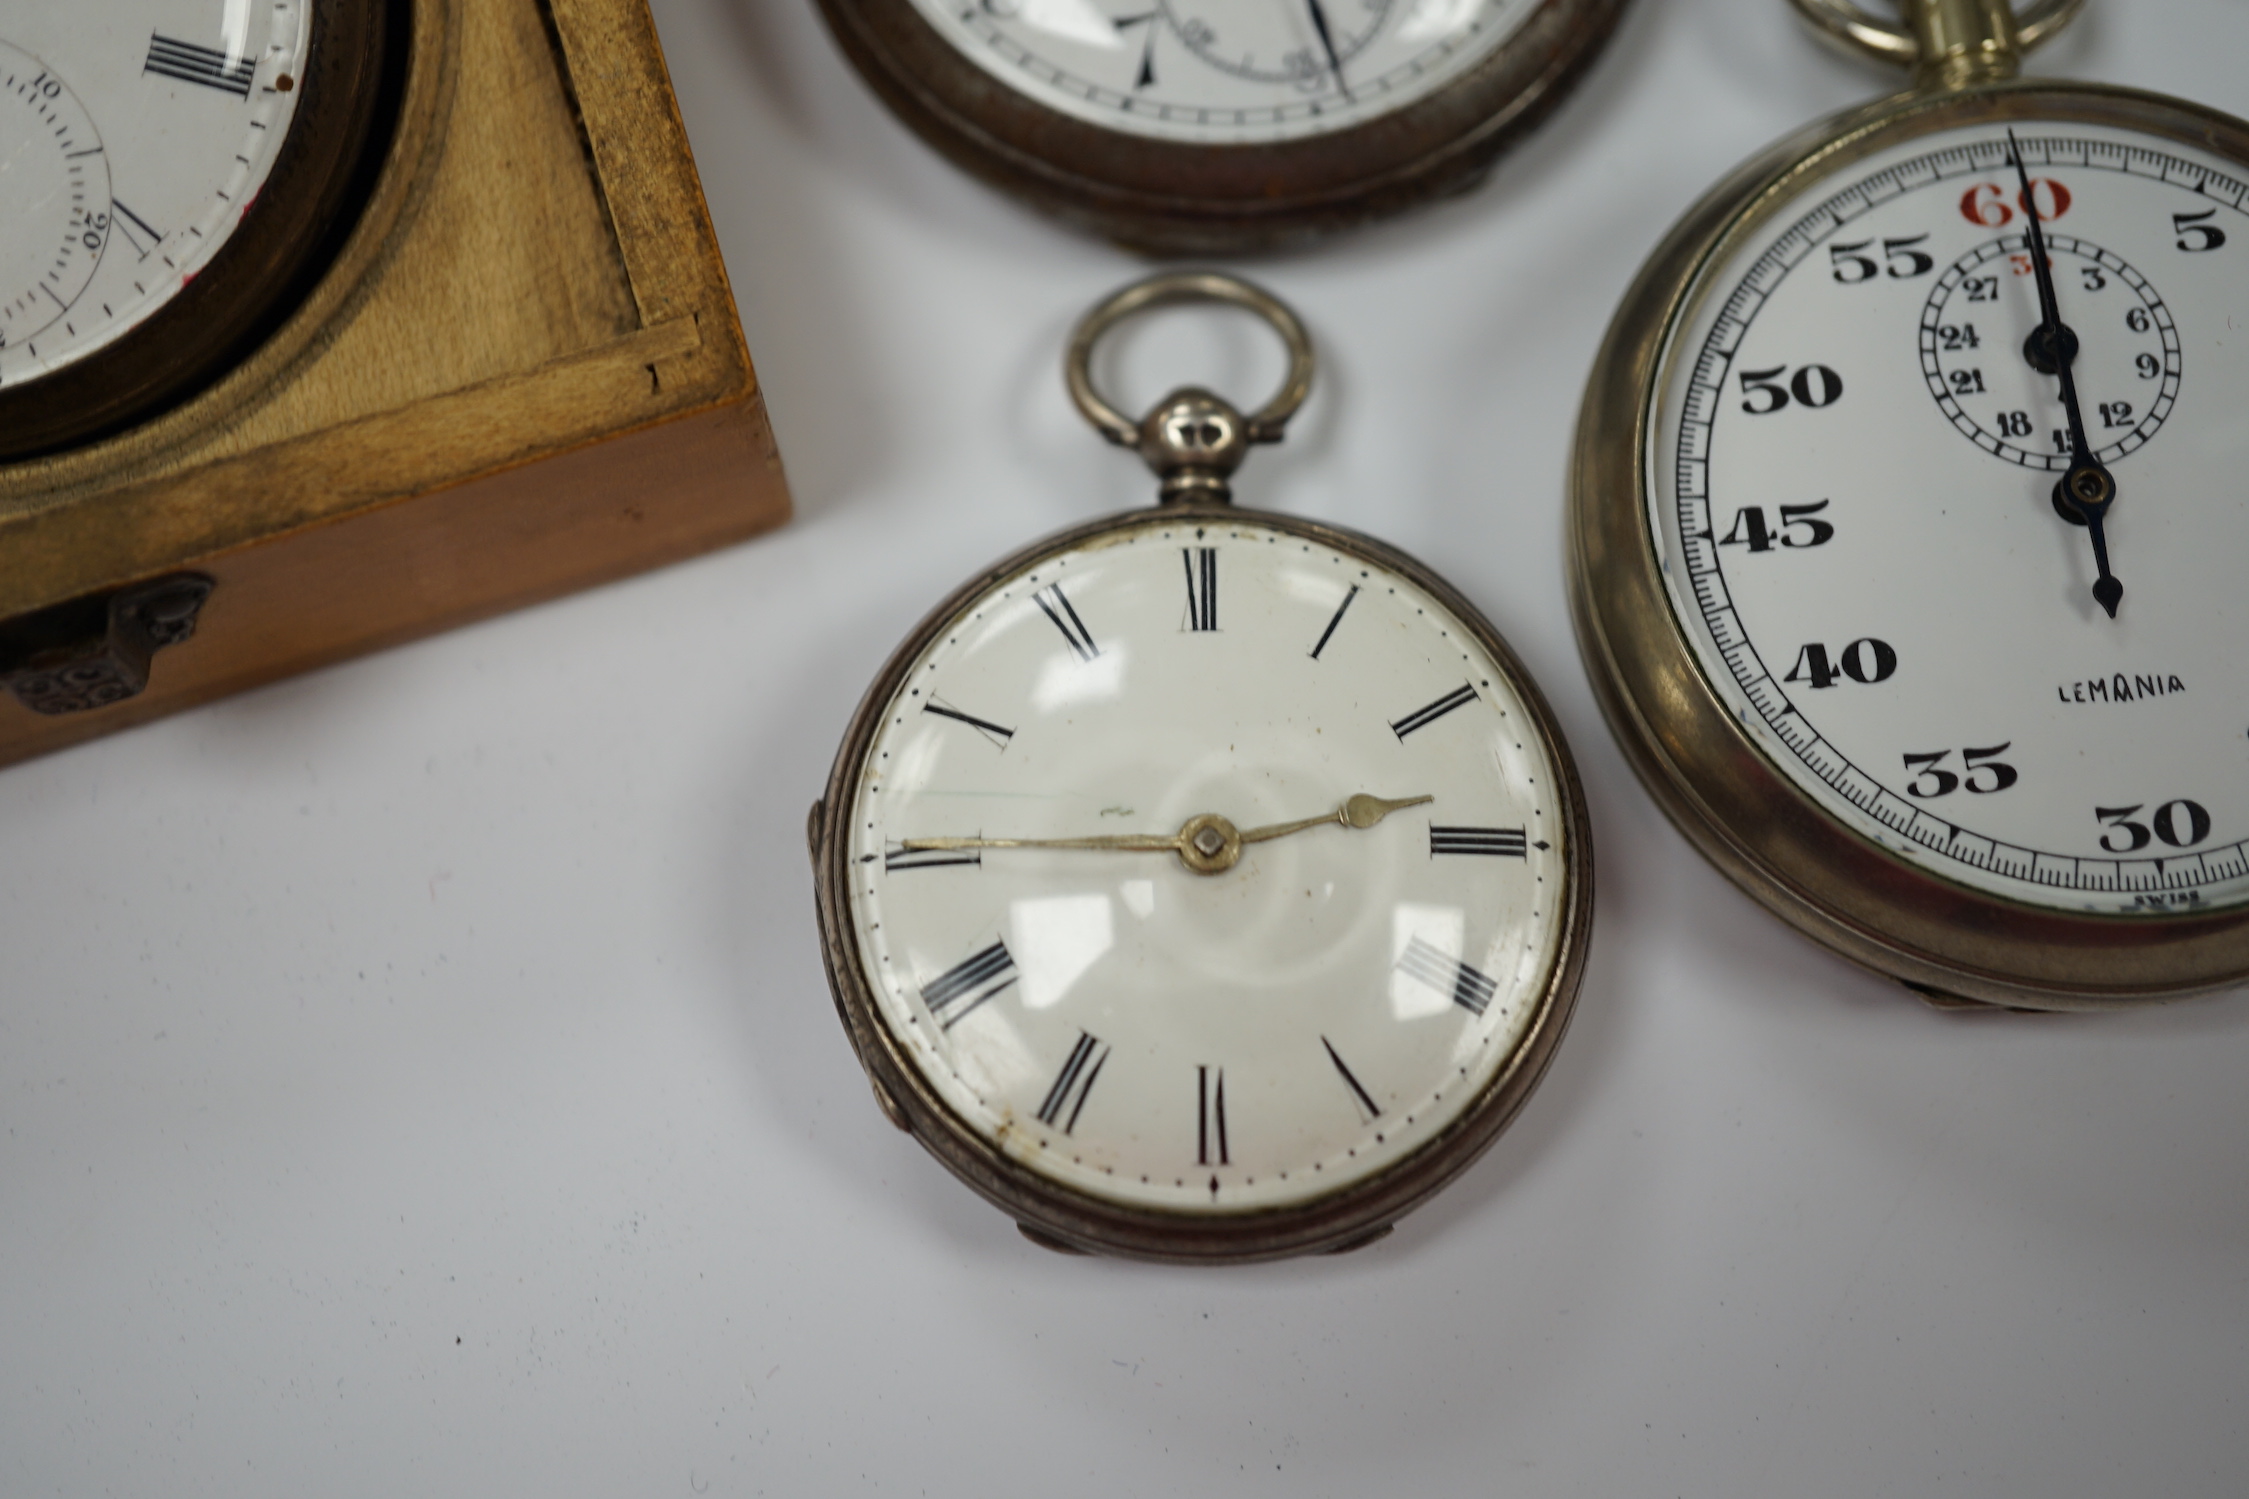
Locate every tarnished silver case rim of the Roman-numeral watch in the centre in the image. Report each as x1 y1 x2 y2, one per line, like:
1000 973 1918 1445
807 503 1592 1263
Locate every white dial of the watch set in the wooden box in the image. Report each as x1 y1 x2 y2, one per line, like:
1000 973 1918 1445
0 0 315 384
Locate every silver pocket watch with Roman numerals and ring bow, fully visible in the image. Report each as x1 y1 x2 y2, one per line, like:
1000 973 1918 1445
810 274 1592 1261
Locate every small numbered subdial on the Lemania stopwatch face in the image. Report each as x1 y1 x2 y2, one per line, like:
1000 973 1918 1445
1921 231 2179 474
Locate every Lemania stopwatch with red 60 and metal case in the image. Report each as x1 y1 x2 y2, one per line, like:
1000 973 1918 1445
1570 0 2249 1009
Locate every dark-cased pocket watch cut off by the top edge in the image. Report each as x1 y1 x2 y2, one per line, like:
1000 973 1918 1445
821 0 1624 254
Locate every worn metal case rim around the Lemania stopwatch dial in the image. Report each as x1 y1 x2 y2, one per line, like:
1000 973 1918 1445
1568 81 2249 1009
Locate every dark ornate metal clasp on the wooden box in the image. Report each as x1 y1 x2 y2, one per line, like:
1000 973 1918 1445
0 573 216 715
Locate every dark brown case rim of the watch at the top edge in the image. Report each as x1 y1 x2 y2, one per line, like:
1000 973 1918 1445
821 0 1626 254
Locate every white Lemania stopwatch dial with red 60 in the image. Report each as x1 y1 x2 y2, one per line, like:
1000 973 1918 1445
1649 119 2249 912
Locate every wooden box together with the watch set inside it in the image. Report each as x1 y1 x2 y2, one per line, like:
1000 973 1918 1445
0 0 787 762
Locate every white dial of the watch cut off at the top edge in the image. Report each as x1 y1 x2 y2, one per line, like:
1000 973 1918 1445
915 0 1536 144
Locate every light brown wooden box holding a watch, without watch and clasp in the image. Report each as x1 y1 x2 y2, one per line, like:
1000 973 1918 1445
0 0 789 764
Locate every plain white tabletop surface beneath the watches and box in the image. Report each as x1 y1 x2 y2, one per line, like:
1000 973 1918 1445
0 0 2249 1499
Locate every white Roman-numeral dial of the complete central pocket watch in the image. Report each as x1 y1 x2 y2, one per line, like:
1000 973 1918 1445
846 515 1577 1214
